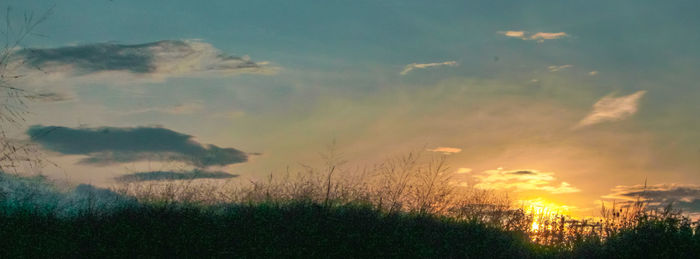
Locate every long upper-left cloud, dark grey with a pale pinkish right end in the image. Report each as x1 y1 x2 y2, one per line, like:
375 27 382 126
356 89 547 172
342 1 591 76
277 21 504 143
14 40 274 78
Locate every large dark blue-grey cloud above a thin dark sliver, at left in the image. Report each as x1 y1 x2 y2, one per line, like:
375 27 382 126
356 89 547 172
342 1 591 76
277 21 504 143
27 125 248 167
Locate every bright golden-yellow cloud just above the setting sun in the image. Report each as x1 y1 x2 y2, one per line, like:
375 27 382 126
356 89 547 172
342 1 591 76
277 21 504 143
474 168 581 194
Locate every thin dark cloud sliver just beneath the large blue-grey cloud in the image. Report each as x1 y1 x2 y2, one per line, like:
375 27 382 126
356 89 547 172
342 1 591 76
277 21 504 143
115 170 238 182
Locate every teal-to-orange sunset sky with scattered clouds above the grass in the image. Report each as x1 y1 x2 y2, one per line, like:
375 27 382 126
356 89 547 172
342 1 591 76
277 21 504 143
0 0 700 218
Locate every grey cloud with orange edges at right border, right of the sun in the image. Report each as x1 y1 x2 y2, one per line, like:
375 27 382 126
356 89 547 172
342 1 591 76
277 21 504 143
602 184 700 213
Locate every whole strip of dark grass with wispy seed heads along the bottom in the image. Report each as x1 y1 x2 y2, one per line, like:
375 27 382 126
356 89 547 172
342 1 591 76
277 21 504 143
0 151 700 258
